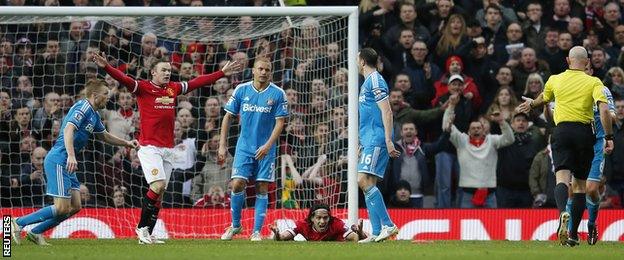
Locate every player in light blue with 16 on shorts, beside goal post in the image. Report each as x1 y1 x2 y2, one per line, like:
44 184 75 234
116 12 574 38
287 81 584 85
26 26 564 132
357 48 400 243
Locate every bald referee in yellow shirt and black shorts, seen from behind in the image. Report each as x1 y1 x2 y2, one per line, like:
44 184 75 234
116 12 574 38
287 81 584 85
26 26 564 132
517 46 613 245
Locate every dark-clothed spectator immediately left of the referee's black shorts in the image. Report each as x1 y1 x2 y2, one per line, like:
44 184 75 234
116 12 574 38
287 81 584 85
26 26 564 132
529 138 557 208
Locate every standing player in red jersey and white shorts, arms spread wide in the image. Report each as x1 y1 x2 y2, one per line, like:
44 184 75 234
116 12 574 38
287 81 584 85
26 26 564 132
93 53 242 244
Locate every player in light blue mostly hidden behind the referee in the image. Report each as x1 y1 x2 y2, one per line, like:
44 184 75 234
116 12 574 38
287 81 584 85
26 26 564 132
566 87 617 246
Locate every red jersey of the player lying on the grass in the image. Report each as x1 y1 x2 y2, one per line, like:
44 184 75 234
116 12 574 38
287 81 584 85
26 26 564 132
289 217 352 241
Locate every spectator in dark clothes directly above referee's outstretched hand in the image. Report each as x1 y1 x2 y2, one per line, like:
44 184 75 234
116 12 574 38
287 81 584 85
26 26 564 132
511 46 552 93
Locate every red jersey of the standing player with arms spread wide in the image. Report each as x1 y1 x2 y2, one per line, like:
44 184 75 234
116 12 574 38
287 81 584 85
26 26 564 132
104 65 224 148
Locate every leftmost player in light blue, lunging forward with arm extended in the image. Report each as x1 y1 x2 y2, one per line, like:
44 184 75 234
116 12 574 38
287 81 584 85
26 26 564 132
12 80 138 245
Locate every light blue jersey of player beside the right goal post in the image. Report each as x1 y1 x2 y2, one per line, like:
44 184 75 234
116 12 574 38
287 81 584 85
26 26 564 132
359 71 389 147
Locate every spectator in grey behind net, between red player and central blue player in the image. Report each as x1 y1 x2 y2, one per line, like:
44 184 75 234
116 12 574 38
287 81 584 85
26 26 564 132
191 134 232 203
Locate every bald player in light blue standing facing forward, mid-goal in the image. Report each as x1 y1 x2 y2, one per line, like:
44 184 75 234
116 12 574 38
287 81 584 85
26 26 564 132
217 59 288 241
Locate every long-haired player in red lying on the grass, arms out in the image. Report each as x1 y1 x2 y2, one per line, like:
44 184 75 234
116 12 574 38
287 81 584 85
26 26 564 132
269 204 367 242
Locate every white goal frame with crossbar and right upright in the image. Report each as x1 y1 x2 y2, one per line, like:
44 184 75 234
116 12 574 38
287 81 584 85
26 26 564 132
0 6 359 236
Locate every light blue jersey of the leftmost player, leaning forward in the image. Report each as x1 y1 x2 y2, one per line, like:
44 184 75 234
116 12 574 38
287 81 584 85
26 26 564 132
47 99 106 164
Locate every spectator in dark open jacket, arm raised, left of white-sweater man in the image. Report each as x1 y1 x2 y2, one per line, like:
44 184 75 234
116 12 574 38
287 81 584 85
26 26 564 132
384 122 449 208
